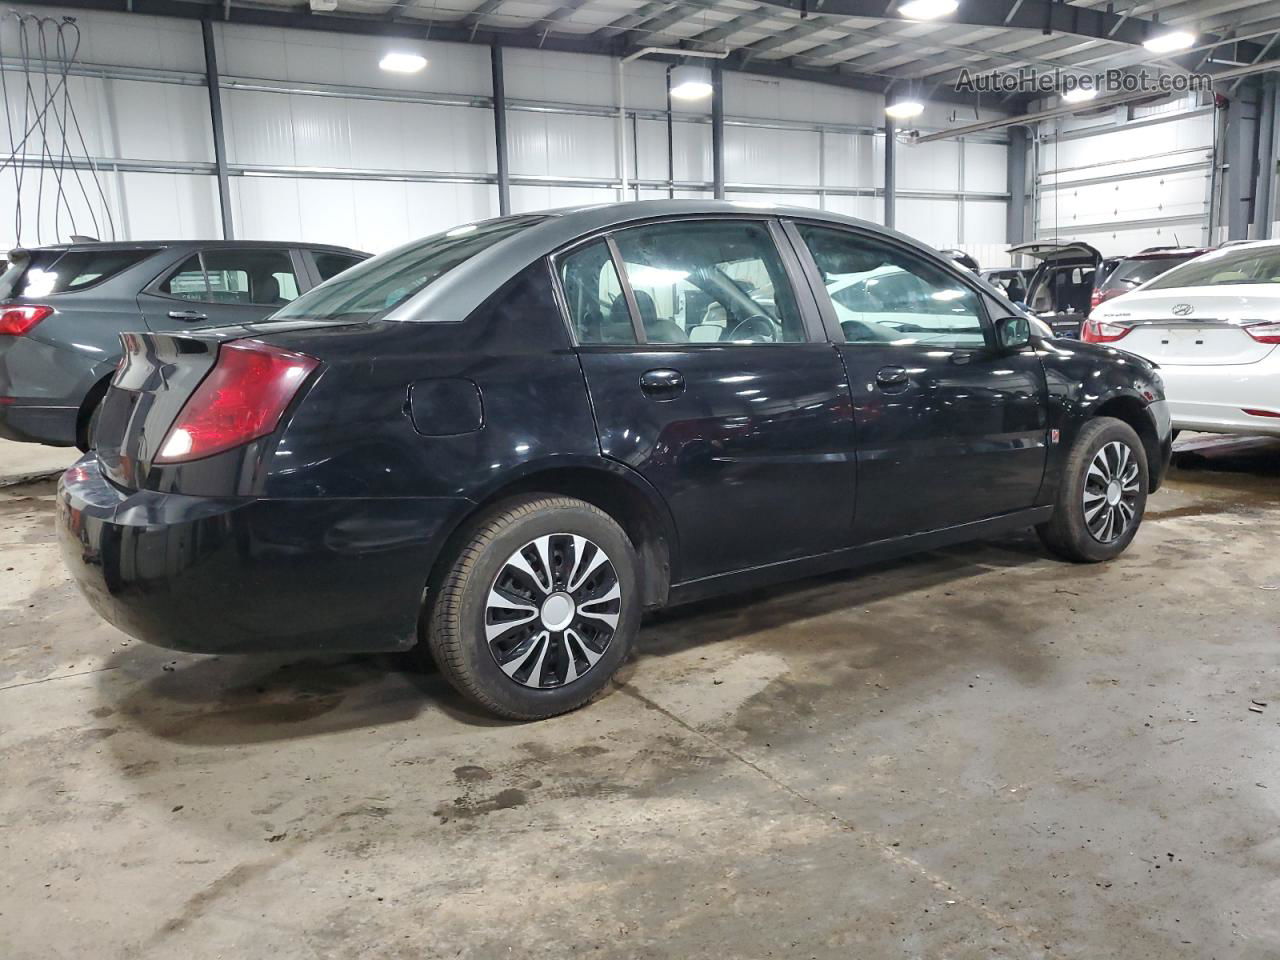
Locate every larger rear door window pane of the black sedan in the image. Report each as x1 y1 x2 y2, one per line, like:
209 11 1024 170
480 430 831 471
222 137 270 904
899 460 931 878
604 220 806 344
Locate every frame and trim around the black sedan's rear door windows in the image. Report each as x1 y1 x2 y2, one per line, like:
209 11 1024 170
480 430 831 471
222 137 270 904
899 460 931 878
549 212 829 352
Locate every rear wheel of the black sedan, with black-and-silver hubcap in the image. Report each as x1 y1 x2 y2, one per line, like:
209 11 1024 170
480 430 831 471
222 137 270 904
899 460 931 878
426 494 641 721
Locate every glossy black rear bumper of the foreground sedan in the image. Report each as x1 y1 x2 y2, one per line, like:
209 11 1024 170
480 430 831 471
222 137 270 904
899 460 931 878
58 456 470 653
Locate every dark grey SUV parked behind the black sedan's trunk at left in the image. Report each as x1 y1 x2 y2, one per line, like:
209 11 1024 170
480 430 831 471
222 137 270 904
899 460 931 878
0 241 369 449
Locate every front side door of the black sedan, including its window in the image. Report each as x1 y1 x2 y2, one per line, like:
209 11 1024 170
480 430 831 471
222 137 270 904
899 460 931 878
788 223 1046 543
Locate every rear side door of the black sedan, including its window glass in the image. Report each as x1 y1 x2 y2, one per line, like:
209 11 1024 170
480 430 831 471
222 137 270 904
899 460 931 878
557 218 855 582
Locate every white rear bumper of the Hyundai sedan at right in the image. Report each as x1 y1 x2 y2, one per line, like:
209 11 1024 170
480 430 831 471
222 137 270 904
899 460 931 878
1160 351 1280 435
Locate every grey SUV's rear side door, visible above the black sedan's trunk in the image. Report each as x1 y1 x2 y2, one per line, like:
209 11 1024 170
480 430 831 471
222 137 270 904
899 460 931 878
138 246 307 330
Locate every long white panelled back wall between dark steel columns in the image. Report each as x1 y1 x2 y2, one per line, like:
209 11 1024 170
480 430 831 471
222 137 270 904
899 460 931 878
0 8 1007 262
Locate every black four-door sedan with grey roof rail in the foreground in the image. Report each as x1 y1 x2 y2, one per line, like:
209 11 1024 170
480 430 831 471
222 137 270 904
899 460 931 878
58 201 1170 719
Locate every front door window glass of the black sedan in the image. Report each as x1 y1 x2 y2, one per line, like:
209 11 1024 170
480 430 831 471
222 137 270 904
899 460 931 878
797 224 987 347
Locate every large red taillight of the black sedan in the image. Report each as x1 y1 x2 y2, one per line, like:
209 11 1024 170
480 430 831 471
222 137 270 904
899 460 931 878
156 340 320 463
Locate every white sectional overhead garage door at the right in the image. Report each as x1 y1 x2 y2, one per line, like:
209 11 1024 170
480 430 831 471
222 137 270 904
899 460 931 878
1036 96 1215 256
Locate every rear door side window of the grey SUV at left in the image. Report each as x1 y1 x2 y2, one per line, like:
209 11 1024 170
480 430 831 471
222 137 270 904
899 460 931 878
160 250 298 306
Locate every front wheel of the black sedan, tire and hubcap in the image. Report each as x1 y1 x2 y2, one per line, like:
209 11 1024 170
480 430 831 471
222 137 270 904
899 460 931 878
1036 417 1148 563
